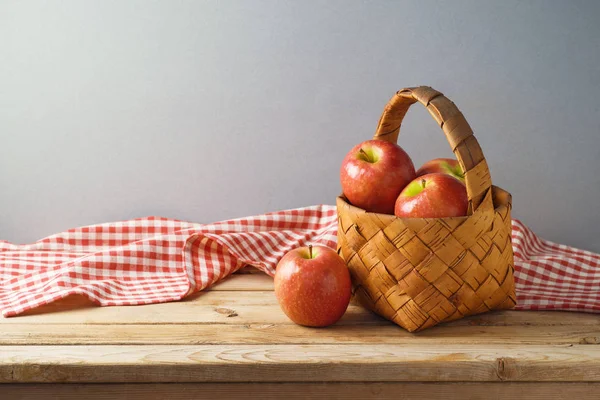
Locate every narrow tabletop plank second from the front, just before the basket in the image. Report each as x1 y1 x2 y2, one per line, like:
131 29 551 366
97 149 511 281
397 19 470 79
0 320 600 345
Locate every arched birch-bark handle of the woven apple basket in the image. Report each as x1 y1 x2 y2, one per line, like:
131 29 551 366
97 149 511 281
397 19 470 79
373 86 494 215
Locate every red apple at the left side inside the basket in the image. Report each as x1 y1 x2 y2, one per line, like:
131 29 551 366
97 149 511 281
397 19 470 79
340 140 416 214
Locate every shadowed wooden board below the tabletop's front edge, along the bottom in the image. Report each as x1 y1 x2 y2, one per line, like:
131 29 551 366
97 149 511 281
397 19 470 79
0 382 600 400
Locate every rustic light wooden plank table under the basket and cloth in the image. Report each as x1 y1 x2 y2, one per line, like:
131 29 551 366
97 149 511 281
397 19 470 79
0 273 600 400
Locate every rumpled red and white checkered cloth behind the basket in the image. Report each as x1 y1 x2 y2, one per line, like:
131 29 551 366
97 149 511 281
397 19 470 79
0 206 600 317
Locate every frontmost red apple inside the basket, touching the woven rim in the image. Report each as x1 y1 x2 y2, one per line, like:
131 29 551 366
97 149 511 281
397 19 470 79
394 173 469 218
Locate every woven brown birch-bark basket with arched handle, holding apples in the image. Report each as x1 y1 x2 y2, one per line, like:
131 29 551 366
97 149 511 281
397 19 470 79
337 86 516 332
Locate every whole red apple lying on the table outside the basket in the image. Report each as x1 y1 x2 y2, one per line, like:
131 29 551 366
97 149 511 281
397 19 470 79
275 246 352 327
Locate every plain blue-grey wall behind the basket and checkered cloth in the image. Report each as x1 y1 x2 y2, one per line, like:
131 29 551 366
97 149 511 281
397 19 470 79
0 0 600 252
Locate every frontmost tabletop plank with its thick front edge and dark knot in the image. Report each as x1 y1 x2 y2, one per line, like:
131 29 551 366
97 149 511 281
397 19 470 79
0 344 600 383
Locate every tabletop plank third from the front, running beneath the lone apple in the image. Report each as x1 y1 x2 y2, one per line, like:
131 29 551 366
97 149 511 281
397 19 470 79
0 291 600 330
